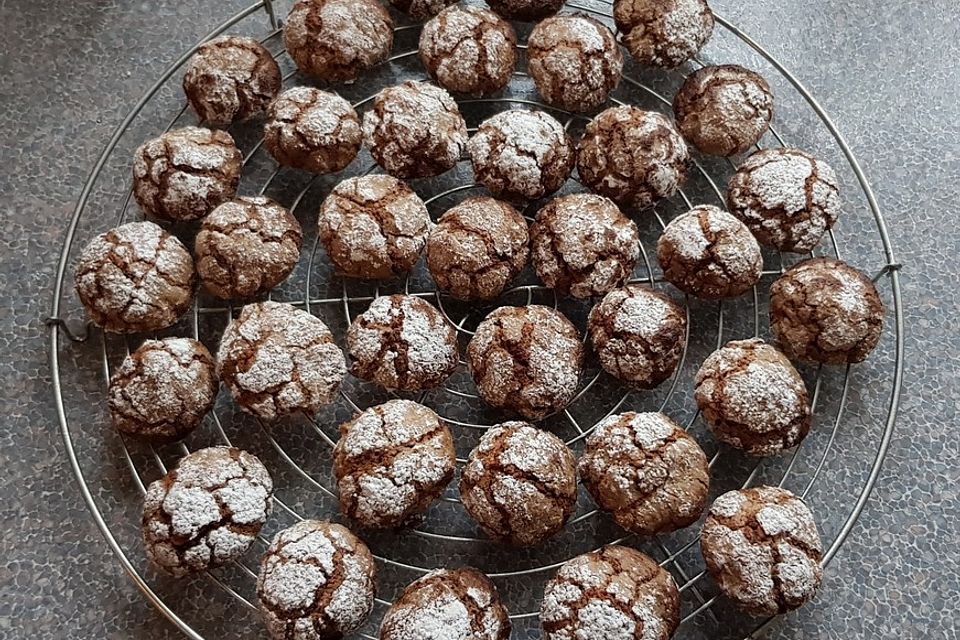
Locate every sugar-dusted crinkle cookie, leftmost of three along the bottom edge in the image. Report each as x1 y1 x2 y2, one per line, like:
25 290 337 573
257 520 377 640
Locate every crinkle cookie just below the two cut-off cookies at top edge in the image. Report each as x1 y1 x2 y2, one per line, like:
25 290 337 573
420 6 517 96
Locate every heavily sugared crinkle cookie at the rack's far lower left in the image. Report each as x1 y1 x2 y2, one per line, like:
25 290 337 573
142 447 273 576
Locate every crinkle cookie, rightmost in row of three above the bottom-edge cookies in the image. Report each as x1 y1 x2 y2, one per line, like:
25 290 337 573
577 412 710 536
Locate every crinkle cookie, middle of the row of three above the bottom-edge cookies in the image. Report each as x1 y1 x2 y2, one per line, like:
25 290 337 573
460 422 577 547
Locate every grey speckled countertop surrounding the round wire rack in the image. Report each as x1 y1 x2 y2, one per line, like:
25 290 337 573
0 0 960 640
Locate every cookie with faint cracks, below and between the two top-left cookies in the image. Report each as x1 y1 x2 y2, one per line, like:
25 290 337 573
263 87 363 174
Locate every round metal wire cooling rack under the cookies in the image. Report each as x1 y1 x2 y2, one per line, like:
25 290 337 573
48 0 903 640
